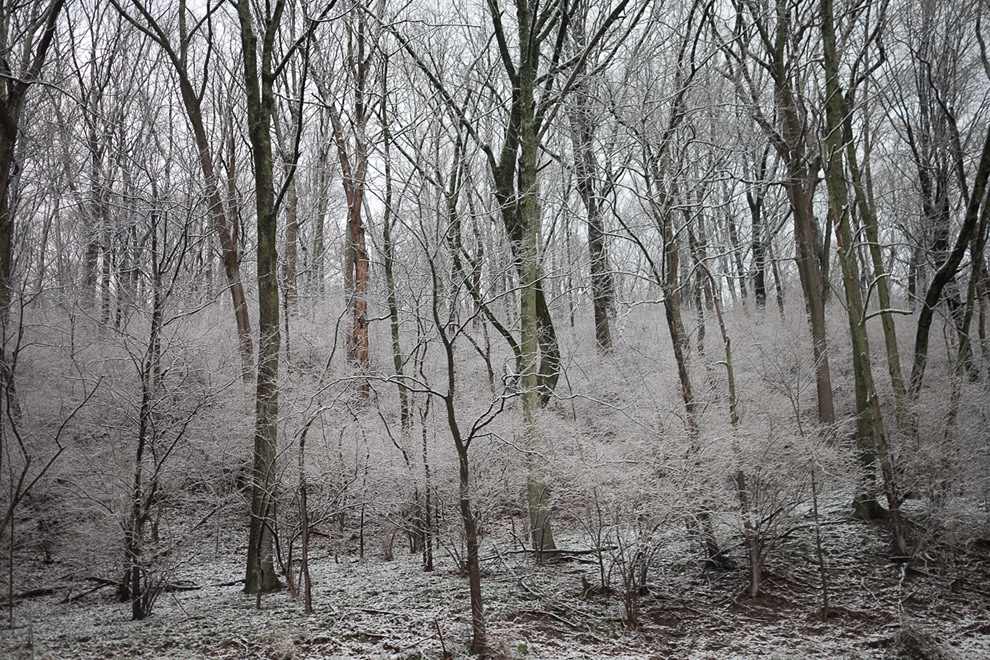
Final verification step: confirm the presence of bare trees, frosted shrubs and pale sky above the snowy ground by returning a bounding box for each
[0,0,990,654]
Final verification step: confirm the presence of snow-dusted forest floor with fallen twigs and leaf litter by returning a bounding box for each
[0,502,990,660]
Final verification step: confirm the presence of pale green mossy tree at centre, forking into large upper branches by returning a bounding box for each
[386,0,647,552]
